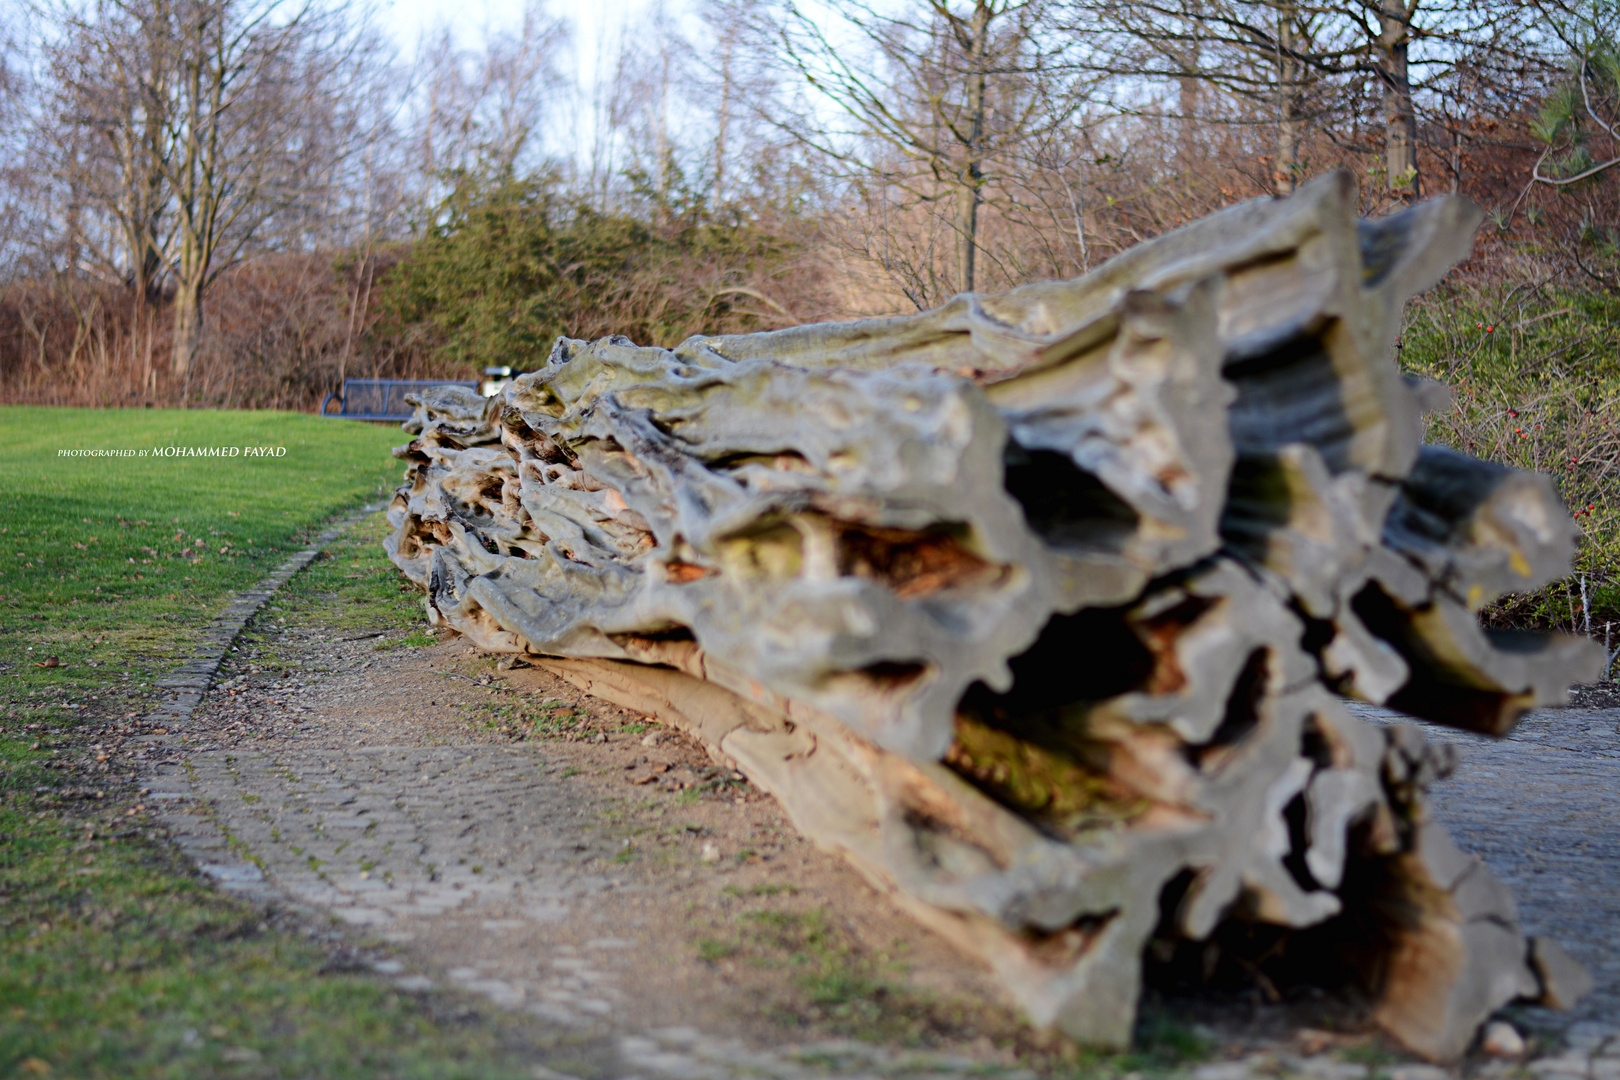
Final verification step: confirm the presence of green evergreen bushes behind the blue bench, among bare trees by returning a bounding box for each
[377,175,810,371]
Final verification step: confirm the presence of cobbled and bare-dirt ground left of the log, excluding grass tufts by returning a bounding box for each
[144,630,1032,1078]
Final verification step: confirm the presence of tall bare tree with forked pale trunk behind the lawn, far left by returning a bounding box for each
[47,0,395,377]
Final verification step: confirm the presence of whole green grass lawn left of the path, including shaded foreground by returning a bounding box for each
[0,408,550,1078]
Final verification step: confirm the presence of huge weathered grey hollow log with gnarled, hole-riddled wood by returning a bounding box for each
[389,176,1601,1059]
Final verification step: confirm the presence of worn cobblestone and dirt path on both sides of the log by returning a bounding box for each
[146,527,1620,1080]
